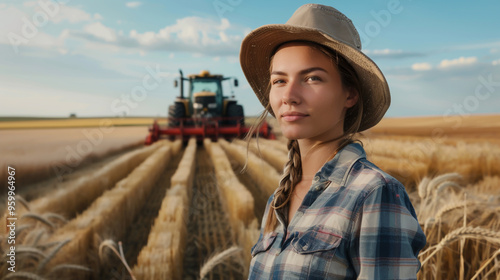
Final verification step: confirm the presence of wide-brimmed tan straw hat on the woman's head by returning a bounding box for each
[240,4,391,131]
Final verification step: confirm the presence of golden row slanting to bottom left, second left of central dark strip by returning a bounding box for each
[44,141,181,279]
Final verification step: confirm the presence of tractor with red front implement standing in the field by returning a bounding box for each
[145,70,275,145]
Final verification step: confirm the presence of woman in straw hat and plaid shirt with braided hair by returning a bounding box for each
[240,4,425,279]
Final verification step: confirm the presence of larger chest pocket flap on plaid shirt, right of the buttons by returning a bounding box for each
[292,229,342,255]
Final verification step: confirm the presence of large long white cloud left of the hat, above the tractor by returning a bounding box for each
[63,17,243,57]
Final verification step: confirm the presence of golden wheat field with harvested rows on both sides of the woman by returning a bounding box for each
[0,116,500,279]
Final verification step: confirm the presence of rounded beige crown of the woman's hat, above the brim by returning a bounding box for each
[286,4,361,50]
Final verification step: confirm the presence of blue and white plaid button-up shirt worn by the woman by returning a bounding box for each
[249,143,426,280]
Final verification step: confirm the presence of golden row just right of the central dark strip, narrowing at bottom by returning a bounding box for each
[204,139,259,278]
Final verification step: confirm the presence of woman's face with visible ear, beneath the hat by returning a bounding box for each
[269,43,358,141]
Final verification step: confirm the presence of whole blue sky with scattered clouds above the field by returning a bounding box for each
[0,0,500,117]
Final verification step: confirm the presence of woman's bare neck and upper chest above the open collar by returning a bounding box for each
[298,139,341,182]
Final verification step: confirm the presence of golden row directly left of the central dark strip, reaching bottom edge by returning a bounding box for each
[133,138,196,280]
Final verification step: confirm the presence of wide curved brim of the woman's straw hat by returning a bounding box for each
[240,24,391,131]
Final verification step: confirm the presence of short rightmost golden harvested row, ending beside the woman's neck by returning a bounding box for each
[232,139,288,173]
